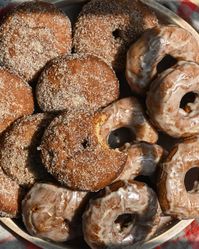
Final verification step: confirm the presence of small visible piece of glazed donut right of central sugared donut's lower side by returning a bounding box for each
[116,142,164,181]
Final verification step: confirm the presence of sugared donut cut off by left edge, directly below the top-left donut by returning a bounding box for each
[0,67,34,133]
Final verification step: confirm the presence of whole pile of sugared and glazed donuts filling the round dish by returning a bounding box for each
[0,0,199,249]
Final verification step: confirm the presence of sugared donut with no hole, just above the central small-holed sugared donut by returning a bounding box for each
[36,54,119,112]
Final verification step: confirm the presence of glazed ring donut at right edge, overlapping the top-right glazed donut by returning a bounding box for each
[146,61,199,137]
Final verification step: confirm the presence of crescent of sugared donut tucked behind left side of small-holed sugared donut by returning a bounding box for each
[0,113,53,187]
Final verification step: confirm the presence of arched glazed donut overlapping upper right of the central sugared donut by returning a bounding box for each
[96,97,158,144]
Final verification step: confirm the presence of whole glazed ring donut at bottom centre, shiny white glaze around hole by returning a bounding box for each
[82,181,160,249]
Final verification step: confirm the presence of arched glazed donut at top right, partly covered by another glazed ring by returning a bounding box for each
[126,25,199,94]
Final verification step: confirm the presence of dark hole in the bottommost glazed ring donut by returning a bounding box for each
[115,214,136,232]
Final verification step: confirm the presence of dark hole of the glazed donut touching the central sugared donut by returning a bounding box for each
[108,127,135,149]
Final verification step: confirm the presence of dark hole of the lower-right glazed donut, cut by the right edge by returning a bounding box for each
[184,167,199,193]
